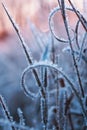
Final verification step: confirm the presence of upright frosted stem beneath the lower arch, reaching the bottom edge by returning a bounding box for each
[40,67,48,130]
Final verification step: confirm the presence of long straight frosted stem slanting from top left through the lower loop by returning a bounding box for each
[2,3,42,87]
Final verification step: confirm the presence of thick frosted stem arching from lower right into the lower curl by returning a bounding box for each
[22,62,87,123]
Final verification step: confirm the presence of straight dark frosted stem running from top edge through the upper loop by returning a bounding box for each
[58,0,84,97]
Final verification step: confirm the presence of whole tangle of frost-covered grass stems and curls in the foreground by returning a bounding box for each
[0,0,87,130]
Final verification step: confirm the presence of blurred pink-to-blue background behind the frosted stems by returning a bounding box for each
[0,0,87,129]
